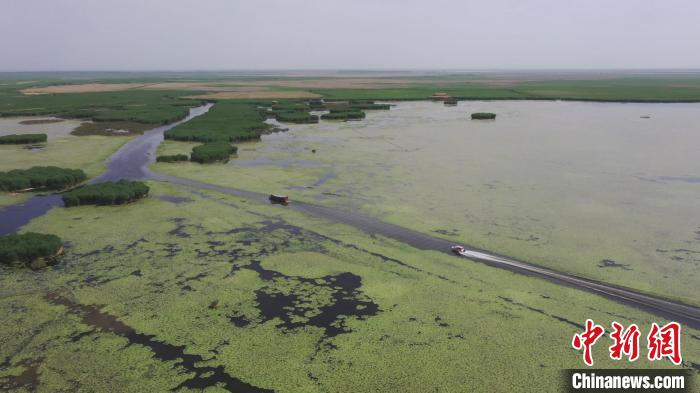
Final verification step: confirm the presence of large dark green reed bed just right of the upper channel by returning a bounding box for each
[165,101,269,142]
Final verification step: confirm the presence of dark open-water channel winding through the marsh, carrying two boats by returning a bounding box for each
[0,104,700,329]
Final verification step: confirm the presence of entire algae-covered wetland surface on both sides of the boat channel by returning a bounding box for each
[0,78,700,392]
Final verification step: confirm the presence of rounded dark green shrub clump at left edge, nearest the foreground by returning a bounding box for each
[0,232,63,265]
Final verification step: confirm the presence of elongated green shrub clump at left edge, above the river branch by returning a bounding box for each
[0,166,87,191]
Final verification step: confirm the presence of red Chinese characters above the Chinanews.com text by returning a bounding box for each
[571,319,682,366]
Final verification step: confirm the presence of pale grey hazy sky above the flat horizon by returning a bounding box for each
[0,0,700,71]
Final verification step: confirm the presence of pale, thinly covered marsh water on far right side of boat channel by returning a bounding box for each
[154,101,700,304]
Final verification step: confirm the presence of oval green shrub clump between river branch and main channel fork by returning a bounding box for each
[63,180,149,207]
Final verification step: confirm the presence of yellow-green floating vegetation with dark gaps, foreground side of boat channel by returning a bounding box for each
[0,181,700,393]
